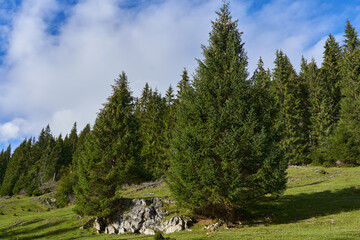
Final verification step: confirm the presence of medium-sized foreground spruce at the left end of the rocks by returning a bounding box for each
[75,72,140,229]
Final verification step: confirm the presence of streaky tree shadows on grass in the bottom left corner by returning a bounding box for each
[0,219,76,240]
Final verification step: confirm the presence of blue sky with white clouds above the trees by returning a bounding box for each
[0,0,360,148]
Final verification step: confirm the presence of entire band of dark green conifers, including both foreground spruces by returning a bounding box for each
[0,3,360,221]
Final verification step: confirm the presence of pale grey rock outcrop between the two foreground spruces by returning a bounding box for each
[94,198,192,235]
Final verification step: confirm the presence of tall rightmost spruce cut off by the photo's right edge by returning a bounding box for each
[326,21,360,165]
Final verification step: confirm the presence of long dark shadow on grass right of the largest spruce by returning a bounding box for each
[255,187,360,224]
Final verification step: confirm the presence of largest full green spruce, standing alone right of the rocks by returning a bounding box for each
[169,3,287,220]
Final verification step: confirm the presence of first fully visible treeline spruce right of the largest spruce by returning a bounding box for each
[271,50,309,164]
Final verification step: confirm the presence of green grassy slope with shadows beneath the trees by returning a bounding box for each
[0,167,360,240]
